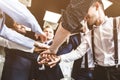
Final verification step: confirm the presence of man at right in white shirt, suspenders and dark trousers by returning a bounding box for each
[40,1,120,80]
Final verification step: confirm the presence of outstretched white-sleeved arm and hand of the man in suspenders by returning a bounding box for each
[38,37,90,68]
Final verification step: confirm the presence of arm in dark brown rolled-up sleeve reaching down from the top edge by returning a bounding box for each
[40,0,101,56]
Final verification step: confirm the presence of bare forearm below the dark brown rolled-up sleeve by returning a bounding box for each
[50,24,71,53]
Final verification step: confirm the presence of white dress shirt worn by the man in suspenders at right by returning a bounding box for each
[61,17,120,66]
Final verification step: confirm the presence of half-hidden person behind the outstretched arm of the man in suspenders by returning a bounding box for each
[71,21,95,80]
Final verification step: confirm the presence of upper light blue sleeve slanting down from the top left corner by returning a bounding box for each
[0,0,43,34]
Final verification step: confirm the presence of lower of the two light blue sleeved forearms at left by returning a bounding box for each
[0,25,35,49]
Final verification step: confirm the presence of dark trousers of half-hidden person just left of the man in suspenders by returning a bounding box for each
[75,68,93,80]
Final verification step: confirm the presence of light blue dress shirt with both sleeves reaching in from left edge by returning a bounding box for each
[0,0,43,49]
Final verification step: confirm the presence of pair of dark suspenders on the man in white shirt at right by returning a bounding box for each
[91,18,118,67]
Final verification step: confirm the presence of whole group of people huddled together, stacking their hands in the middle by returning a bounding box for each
[0,0,120,80]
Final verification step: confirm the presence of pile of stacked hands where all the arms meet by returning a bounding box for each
[34,41,60,68]
